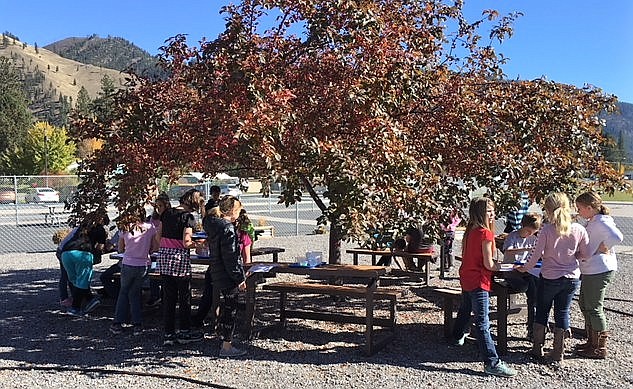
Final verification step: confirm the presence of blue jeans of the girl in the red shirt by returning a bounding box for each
[453,289,500,367]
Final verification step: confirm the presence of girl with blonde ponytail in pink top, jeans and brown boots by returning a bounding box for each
[517,193,589,361]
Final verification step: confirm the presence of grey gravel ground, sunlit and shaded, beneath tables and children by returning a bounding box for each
[0,236,633,388]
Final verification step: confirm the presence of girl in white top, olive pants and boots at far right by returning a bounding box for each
[576,192,623,359]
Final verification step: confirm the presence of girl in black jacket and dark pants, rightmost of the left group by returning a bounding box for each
[204,196,246,357]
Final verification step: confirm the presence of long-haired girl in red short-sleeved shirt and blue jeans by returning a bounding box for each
[453,197,517,377]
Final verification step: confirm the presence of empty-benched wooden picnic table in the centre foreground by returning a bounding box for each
[242,263,395,354]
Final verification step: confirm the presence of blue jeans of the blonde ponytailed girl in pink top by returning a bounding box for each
[534,276,580,330]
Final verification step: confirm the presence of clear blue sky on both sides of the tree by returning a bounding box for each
[0,0,633,103]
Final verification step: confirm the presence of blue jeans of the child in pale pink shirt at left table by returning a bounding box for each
[114,265,147,325]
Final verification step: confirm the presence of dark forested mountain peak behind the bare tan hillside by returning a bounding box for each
[44,34,164,79]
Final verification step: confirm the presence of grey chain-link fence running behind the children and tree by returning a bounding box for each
[0,176,633,253]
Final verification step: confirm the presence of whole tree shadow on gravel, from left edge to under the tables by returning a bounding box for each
[0,264,524,376]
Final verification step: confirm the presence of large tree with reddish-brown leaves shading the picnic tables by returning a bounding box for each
[69,0,621,262]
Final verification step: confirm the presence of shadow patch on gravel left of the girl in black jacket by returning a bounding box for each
[0,269,222,369]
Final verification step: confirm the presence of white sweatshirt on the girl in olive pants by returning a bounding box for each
[580,214,624,274]
